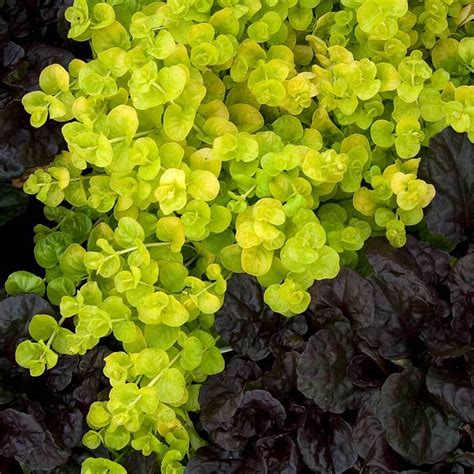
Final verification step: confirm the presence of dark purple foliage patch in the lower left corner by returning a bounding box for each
[0,294,110,473]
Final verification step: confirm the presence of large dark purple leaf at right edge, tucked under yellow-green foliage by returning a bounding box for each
[419,128,474,244]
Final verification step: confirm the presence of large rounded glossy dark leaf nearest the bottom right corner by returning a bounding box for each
[377,369,459,465]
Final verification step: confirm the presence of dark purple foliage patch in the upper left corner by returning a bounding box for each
[0,0,90,225]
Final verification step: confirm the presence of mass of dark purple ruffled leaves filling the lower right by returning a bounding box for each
[187,238,474,474]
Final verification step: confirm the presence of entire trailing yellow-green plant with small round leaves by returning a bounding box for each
[6,0,474,474]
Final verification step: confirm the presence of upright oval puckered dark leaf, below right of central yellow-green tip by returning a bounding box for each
[297,322,356,413]
